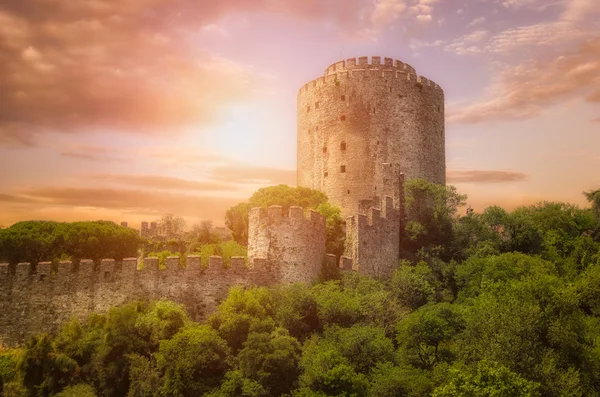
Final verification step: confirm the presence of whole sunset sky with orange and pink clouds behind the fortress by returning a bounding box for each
[0,0,600,227]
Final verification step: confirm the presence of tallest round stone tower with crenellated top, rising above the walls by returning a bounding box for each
[297,57,446,216]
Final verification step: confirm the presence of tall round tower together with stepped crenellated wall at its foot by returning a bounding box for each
[297,57,446,276]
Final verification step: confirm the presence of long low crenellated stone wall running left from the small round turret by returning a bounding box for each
[0,255,278,345]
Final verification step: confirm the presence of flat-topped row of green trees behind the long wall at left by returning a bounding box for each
[0,221,141,263]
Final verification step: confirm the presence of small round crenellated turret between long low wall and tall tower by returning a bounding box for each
[248,205,325,284]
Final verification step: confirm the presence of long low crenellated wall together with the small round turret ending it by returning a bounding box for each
[0,206,328,345]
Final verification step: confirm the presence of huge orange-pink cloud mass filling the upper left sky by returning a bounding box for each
[0,0,400,146]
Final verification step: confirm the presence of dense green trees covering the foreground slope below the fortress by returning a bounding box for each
[0,182,600,397]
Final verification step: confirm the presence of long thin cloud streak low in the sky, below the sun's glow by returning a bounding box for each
[89,174,237,191]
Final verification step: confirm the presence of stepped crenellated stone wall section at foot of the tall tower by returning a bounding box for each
[341,196,400,277]
